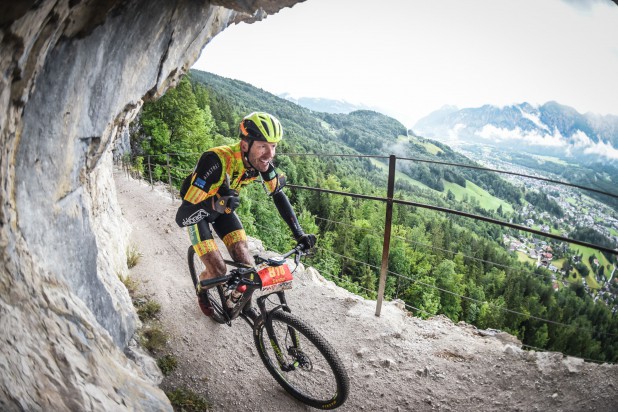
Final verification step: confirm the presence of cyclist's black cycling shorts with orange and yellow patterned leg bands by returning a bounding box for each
[187,213,247,256]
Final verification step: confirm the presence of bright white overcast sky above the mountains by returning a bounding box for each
[193,0,618,127]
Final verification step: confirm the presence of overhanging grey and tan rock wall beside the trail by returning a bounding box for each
[0,0,297,411]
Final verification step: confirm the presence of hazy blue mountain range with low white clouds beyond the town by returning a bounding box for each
[413,101,618,163]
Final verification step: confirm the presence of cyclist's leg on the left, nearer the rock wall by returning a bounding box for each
[187,219,227,280]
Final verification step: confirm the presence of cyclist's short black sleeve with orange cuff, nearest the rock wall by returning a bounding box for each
[183,152,223,204]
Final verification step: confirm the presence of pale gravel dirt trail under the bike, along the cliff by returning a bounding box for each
[115,172,618,411]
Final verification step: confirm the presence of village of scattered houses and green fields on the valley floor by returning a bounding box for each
[502,178,618,312]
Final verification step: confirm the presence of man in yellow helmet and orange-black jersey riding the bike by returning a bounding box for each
[176,112,315,316]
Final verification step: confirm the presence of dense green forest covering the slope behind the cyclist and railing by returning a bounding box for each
[127,70,618,362]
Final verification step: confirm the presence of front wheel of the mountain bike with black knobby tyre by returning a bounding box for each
[253,310,350,409]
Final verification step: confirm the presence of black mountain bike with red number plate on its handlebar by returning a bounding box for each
[188,245,350,409]
